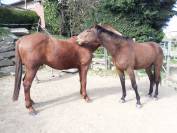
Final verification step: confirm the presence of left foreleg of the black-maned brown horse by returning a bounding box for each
[118,70,126,103]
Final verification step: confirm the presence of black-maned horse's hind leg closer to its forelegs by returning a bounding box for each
[146,66,154,96]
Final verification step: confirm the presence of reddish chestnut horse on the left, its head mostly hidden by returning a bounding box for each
[13,33,99,114]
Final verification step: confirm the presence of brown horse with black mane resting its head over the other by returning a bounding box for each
[78,25,163,107]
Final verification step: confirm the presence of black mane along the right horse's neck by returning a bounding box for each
[95,25,133,41]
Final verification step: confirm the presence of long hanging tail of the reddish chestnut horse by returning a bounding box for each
[13,40,22,101]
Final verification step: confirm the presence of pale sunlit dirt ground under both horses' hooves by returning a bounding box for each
[0,70,177,133]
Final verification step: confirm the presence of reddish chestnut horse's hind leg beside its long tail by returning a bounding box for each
[23,69,37,114]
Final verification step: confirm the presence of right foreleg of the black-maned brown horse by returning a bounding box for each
[127,69,142,108]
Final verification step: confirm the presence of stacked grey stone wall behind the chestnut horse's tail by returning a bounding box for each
[0,34,17,76]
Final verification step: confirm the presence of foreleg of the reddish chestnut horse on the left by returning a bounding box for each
[79,66,90,102]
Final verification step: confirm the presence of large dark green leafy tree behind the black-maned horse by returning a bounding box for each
[92,0,176,42]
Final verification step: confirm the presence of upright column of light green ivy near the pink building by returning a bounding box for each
[44,0,61,34]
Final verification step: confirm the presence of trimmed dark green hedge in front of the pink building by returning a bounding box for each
[0,8,39,25]
